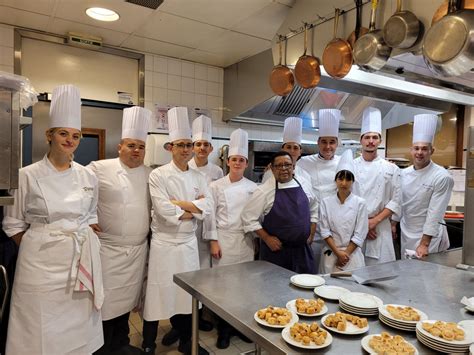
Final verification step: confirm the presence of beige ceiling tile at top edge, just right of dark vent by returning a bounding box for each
[159,0,273,28]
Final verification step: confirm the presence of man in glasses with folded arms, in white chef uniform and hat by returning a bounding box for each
[143,107,213,354]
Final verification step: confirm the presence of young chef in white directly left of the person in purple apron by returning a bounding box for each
[211,128,257,349]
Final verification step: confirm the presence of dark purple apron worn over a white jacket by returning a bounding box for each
[260,179,316,274]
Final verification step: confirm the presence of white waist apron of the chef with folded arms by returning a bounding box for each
[143,233,199,321]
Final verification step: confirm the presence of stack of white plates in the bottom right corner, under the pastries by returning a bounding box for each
[416,320,474,354]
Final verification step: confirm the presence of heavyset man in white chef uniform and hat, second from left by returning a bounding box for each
[88,106,152,354]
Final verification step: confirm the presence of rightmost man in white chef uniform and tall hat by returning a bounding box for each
[394,114,454,257]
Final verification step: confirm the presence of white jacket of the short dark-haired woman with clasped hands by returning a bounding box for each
[319,193,369,273]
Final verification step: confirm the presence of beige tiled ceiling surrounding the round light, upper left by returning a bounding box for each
[0,0,296,67]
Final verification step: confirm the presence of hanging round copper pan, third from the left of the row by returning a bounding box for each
[323,9,352,79]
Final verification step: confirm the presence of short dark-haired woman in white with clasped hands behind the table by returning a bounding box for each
[319,150,369,274]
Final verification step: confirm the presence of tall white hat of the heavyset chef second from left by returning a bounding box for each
[122,106,151,142]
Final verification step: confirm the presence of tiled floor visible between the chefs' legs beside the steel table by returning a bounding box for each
[129,313,255,355]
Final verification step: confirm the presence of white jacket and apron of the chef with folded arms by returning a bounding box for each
[143,161,213,321]
